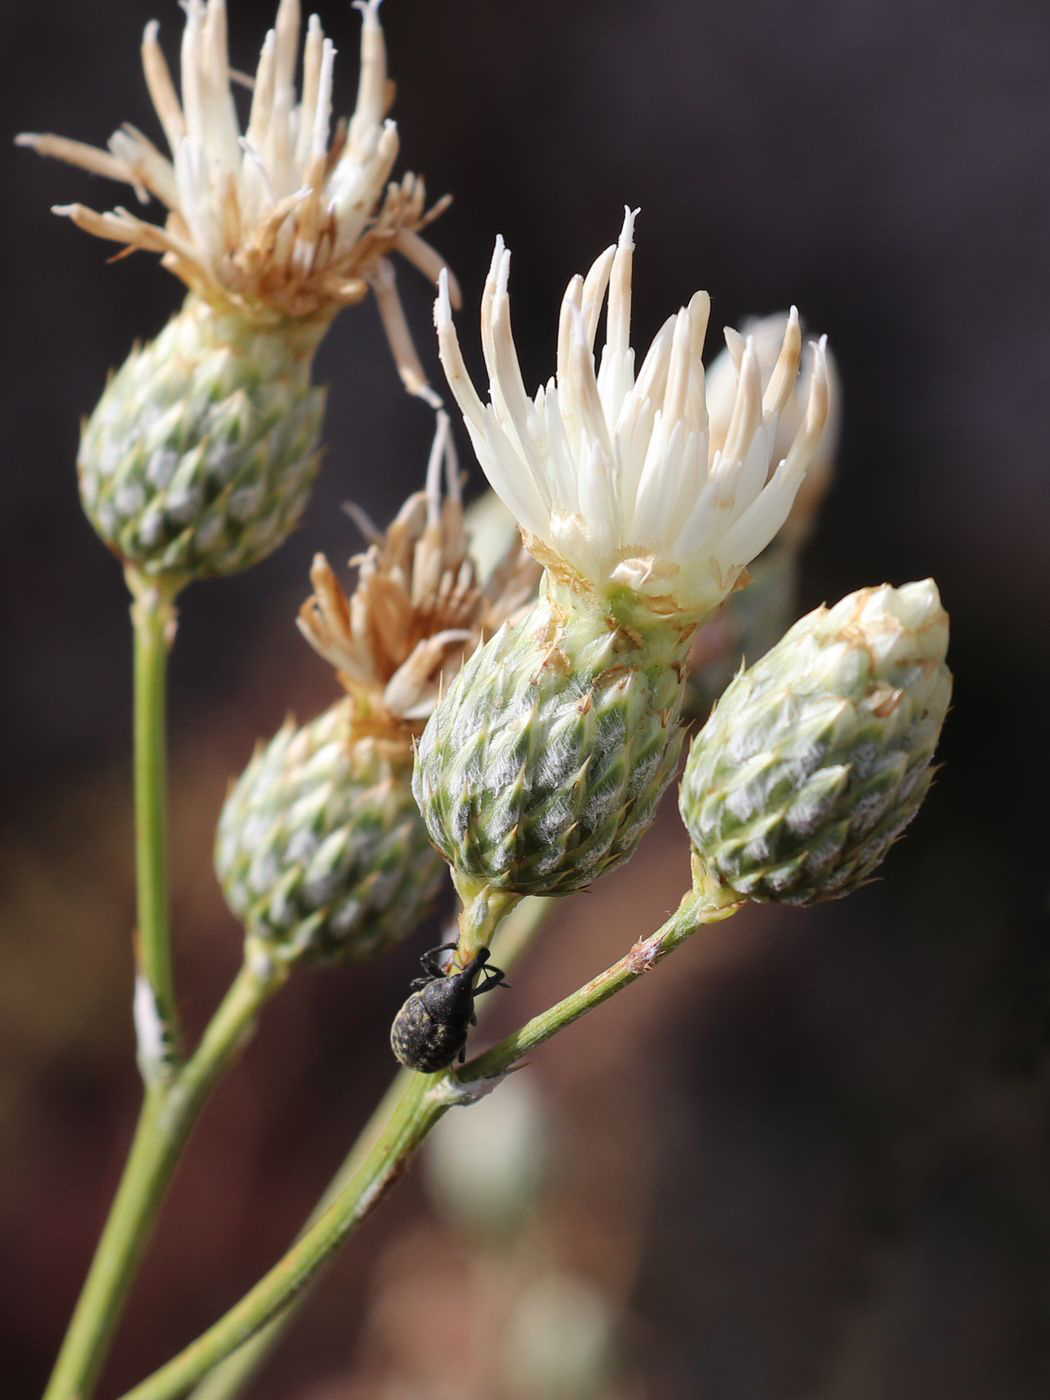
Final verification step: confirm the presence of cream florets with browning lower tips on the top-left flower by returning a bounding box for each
[17,0,456,343]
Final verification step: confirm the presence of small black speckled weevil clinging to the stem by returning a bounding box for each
[391,944,510,1072]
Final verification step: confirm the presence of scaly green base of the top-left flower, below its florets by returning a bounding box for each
[78,295,326,580]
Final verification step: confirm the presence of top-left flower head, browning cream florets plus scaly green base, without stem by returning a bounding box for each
[18,0,444,588]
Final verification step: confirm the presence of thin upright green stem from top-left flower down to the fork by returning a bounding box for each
[127,570,178,1085]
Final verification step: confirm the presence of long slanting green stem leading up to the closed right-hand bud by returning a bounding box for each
[122,892,739,1400]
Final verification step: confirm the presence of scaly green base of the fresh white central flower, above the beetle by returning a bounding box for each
[413,574,693,895]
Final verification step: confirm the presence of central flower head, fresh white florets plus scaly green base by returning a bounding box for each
[414,210,827,918]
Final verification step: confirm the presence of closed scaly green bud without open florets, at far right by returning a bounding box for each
[680,578,952,904]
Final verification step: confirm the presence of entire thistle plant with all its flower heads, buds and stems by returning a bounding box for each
[21,0,951,1400]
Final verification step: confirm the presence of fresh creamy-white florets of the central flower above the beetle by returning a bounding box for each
[435,209,827,617]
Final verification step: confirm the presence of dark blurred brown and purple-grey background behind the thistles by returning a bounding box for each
[0,0,1050,1400]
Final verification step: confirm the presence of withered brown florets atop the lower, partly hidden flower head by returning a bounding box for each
[300,413,539,732]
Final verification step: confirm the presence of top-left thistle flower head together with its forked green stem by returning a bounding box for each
[18,0,453,1396]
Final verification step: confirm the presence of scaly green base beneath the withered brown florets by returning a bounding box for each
[216,699,444,963]
